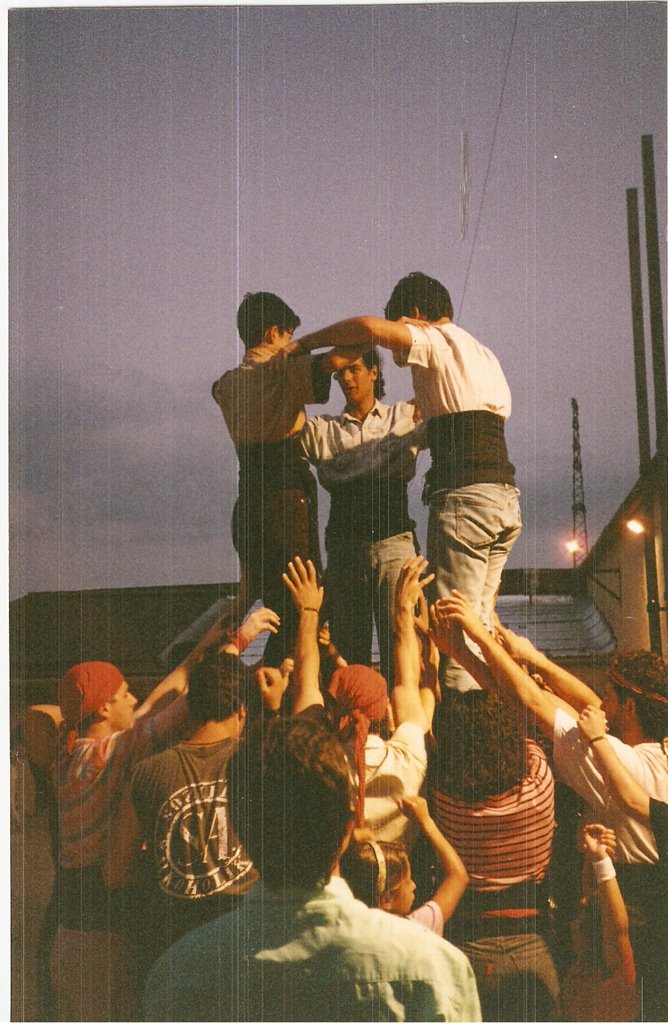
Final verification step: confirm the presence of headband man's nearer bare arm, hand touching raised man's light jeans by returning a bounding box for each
[433,591,556,737]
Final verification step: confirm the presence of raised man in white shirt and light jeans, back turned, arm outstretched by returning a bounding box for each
[288,271,521,690]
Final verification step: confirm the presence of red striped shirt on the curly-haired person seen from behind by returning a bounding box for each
[432,739,554,892]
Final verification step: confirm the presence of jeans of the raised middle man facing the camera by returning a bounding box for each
[325,530,415,687]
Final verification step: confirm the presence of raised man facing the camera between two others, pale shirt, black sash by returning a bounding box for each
[301,348,422,684]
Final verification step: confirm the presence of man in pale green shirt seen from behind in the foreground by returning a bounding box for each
[144,719,481,1021]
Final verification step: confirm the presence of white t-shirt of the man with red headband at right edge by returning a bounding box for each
[554,708,668,864]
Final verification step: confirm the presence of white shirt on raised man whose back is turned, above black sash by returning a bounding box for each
[407,324,511,421]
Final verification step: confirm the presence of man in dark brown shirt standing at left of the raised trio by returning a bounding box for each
[212,292,352,666]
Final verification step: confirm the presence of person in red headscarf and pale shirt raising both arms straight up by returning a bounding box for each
[283,557,433,845]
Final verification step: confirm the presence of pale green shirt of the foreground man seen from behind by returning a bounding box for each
[144,878,482,1021]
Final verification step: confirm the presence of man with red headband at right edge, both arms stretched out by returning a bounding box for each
[430,592,668,1020]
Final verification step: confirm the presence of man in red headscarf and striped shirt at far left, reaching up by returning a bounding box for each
[50,602,270,1021]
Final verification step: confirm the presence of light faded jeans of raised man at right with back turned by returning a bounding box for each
[427,483,521,690]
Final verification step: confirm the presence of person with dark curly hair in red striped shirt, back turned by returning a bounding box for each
[430,689,559,1021]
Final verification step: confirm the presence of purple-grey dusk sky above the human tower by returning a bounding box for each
[9,3,666,597]
